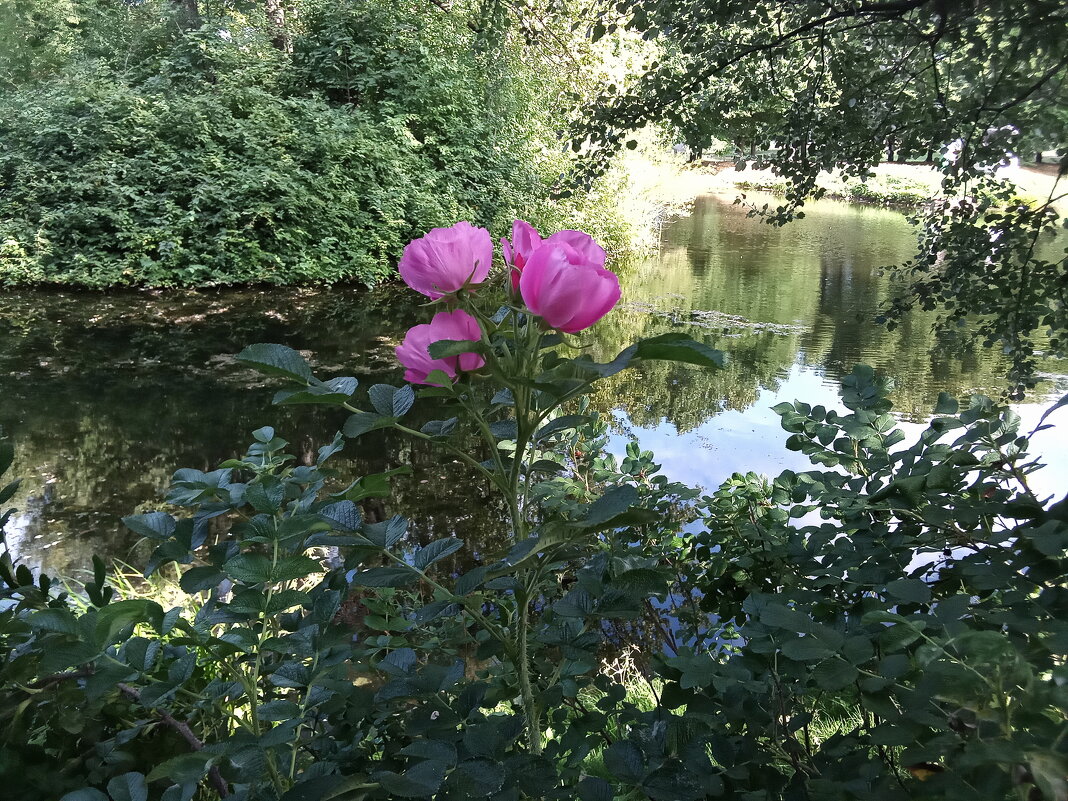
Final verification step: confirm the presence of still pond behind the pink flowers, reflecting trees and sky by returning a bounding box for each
[0,195,1068,575]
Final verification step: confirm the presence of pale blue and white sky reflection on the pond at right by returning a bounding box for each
[609,365,1068,499]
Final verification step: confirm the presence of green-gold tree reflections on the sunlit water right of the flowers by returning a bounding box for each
[596,197,1056,430]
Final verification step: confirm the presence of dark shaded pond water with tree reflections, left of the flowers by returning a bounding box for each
[0,288,499,572]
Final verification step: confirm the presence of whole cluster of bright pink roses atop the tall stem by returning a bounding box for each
[396,220,619,383]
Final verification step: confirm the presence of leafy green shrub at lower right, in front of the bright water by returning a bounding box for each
[663,367,1068,799]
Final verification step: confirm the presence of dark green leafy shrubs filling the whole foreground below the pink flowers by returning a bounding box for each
[0,360,1068,801]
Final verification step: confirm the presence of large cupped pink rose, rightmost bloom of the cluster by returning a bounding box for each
[519,243,621,333]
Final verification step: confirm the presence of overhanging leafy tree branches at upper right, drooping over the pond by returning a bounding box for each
[572,0,1068,393]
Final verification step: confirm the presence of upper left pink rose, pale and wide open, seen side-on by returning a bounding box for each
[399,222,493,300]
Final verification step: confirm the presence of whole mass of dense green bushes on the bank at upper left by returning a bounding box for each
[0,0,622,287]
